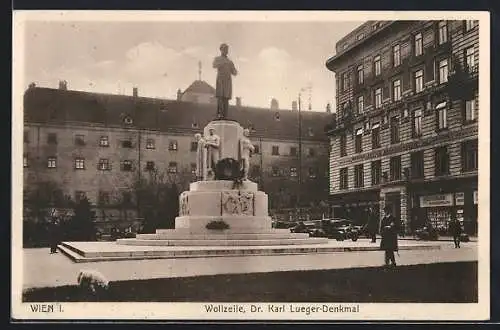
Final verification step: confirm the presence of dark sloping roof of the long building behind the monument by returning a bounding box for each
[24,87,332,141]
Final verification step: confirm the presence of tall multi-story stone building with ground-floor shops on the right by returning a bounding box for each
[326,21,479,233]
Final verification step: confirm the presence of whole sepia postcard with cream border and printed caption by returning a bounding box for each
[11,11,490,321]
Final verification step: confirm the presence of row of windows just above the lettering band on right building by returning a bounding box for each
[340,100,476,157]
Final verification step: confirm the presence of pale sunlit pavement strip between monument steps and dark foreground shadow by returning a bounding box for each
[22,242,478,288]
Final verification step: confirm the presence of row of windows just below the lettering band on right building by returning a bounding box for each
[339,140,478,190]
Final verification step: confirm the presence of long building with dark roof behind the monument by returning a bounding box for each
[24,82,330,232]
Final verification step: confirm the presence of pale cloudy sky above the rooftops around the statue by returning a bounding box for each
[25,21,363,111]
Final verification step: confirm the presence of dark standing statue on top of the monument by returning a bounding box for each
[213,44,238,119]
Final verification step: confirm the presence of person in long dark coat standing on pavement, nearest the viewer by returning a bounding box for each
[380,205,400,267]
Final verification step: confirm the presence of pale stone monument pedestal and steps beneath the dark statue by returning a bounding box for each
[117,120,327,246]
